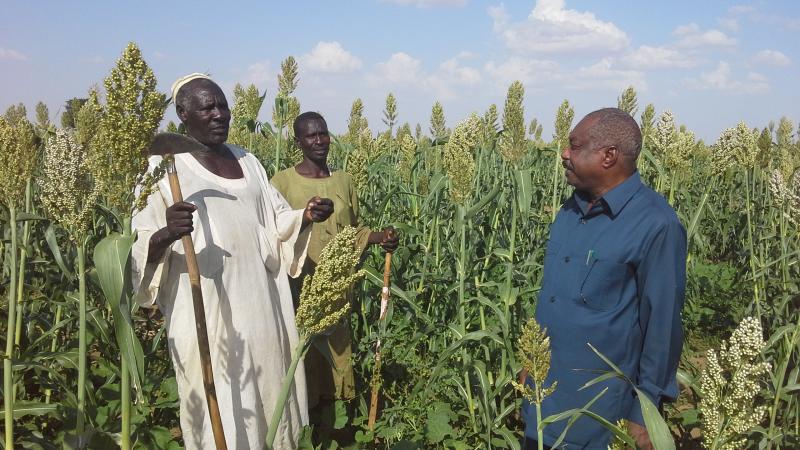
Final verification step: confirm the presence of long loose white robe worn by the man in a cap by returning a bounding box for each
[132,145,311,449]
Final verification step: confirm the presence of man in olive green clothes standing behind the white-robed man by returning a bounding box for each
[271,112,398,440]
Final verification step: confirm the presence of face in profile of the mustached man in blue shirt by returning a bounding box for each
[561,118,604,192]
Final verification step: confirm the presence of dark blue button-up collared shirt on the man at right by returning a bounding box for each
[523,173,686,450]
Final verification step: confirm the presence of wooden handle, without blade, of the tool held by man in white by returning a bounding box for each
[164,154,228,450]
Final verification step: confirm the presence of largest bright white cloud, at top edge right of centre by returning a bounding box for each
[488,0,628,53]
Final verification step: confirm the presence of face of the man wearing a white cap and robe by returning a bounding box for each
[178,82,231,145]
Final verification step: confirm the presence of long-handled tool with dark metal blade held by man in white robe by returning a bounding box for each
[150,133,228,450]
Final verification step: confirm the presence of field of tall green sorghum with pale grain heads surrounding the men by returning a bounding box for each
[0,44,800,449]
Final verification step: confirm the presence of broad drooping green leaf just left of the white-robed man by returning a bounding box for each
[94,233,144,402]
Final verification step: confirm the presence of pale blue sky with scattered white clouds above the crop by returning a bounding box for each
[0,0,800,142]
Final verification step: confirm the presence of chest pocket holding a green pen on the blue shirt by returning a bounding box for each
[576,259,630,311]
